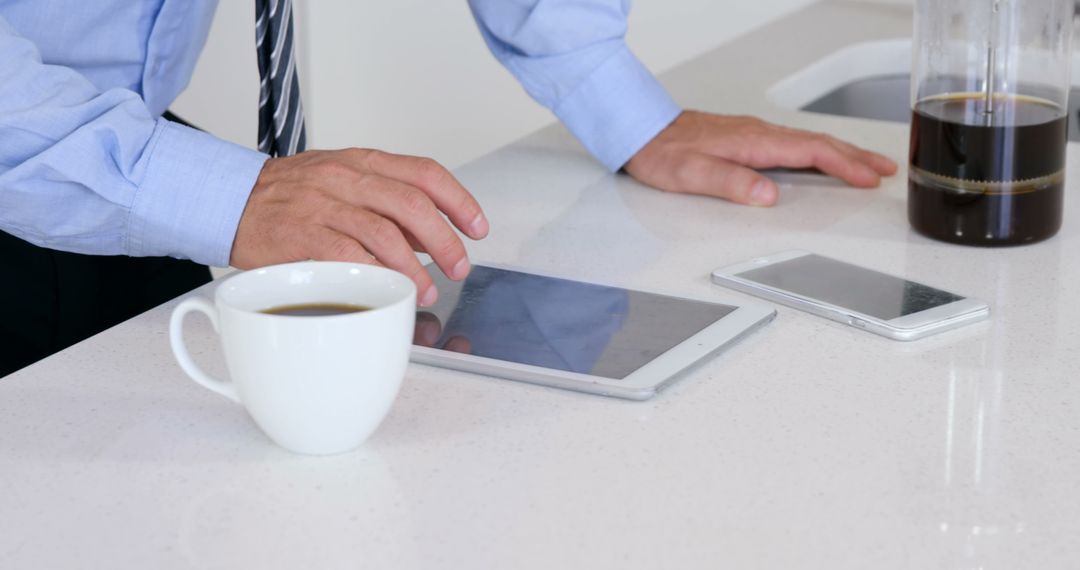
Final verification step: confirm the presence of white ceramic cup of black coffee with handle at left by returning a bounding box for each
[170,261,416,454]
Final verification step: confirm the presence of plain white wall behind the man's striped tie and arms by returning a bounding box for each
[173,0,812,167]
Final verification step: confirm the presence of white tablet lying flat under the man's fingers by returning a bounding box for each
[411,266,775,399]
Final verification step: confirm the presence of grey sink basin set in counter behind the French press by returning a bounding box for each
[799,73,1080,141]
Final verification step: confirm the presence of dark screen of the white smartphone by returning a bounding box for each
[735,254,963,321]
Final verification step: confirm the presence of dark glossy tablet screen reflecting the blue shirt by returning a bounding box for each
[414,266,735,379]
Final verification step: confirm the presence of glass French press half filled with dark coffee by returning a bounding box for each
[908,0,1074,246]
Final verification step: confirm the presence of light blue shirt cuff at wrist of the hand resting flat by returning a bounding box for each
[554,46,683,172]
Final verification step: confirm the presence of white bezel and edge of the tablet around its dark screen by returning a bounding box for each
[410,263,777,399]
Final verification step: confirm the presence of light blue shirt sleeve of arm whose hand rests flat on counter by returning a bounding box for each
[469,0,681,171]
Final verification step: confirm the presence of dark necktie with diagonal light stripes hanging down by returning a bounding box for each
[255,0,306,157]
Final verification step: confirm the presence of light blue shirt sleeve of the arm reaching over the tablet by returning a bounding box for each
[0,17,268,266]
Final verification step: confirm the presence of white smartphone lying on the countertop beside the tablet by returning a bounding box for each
[713,250,990,340]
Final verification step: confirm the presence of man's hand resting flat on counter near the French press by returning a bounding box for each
[625,111,896,206]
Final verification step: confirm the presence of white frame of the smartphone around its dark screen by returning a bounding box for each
[713,249,989,341]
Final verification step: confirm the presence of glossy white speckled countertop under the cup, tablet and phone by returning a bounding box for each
[0,2,1080,570]
